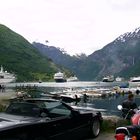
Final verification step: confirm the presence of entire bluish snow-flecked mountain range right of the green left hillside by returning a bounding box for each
[33,28,140,80]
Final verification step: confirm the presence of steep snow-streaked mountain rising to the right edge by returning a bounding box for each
[88,28,140,79]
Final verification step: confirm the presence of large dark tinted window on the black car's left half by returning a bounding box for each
[5,102,40,117]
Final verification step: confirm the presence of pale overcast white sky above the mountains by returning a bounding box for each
[0,0,140,55]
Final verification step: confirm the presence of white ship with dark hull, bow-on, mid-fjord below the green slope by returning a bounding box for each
[54,72,67,82]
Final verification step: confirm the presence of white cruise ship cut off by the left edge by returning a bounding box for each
[0,66,16,84]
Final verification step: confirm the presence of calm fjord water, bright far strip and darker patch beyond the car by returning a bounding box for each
[7,82,140,116]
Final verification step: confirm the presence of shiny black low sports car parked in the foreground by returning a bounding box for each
[0,98,103,140]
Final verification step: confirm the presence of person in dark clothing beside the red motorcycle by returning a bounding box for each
[122,93,137,119]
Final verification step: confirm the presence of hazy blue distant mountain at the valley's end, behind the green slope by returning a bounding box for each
[33,42,100,81]
